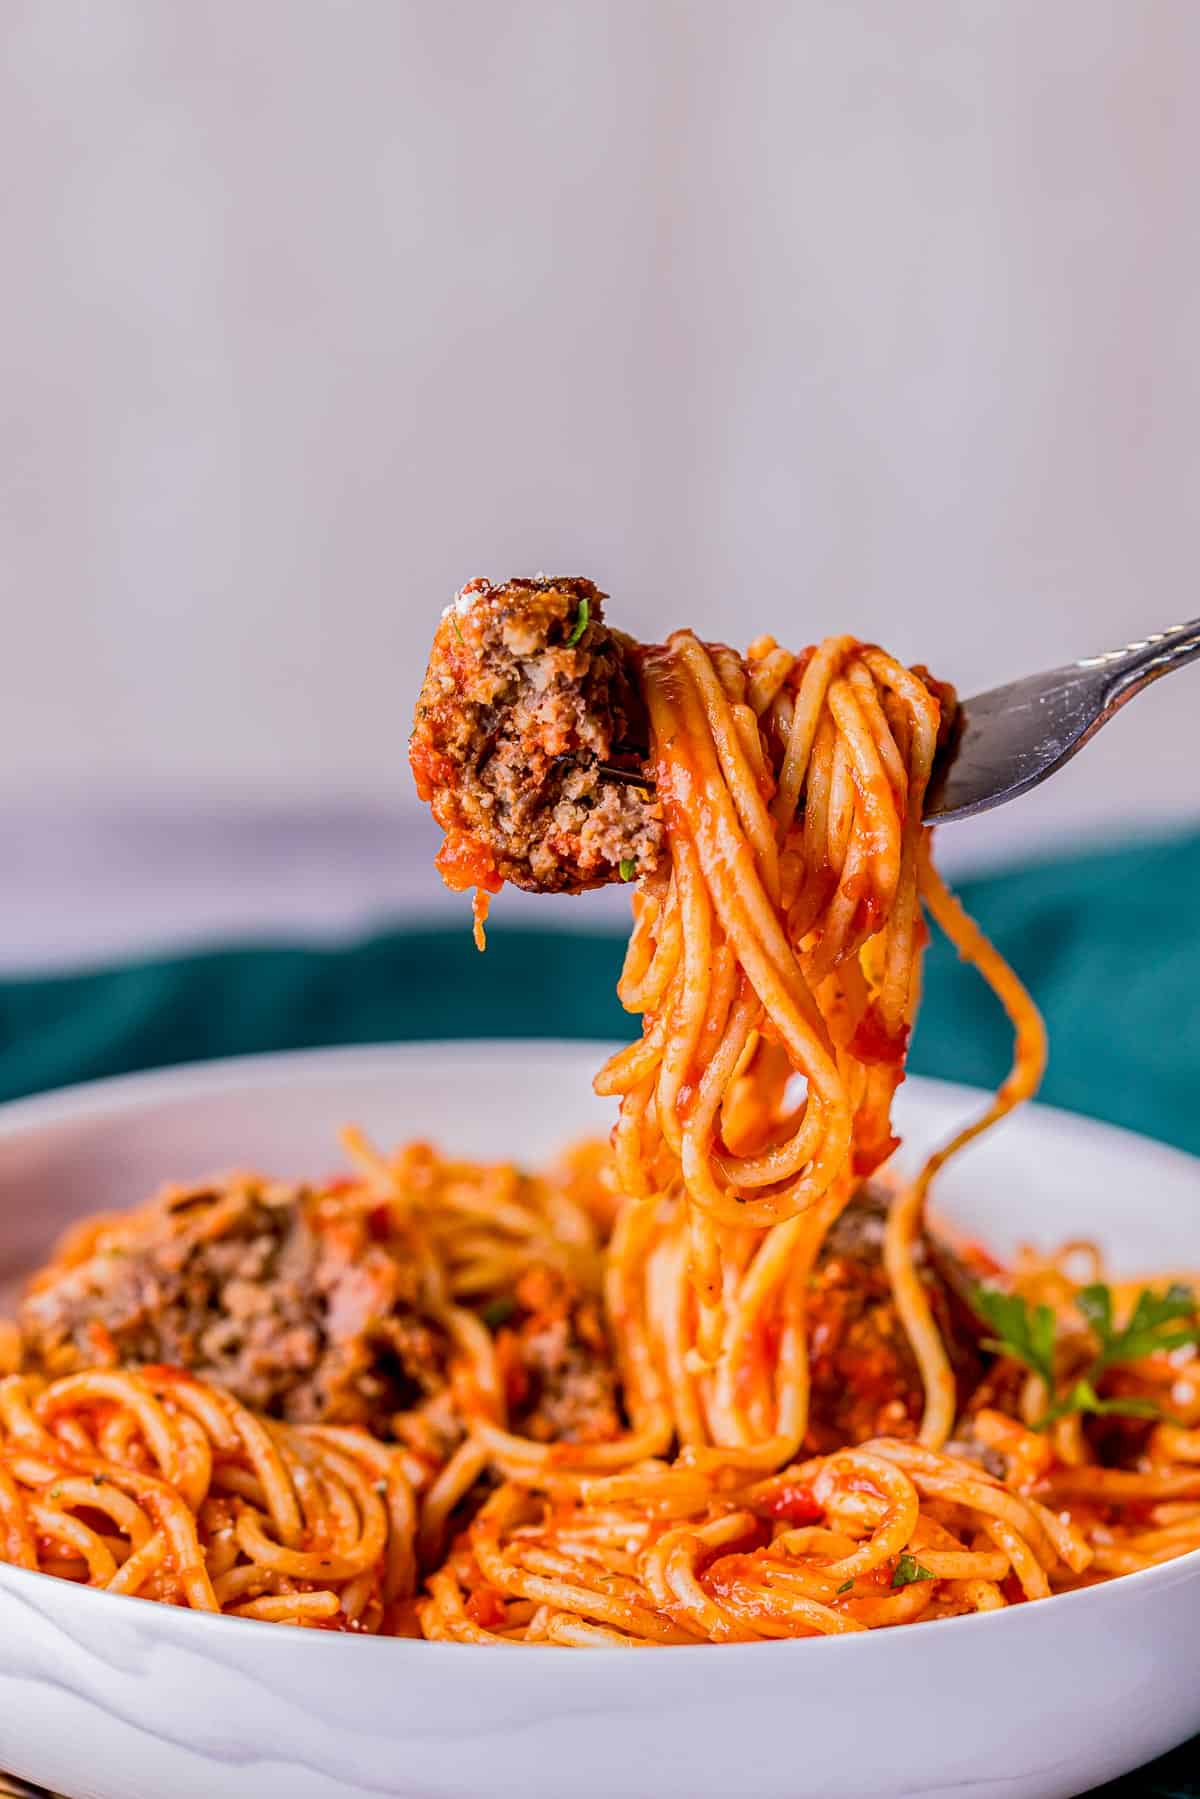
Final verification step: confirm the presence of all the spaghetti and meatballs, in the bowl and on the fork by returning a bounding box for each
[0,597,1200,1648]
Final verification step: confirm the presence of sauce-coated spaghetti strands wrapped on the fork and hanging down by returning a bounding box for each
[596,631,1043,1468]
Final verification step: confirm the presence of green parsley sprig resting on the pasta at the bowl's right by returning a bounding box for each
[973,1281,1200,1430]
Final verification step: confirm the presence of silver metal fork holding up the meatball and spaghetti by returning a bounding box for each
[925,619,1200,824]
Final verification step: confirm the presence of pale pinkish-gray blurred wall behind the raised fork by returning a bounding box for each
[0,0,1200,964]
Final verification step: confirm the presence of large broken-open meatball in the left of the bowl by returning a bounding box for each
[18,1177,450,1436]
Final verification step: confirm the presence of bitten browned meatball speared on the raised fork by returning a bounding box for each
[408,576,664,892]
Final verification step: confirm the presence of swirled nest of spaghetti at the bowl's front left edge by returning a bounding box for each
[0,1367,416,1633]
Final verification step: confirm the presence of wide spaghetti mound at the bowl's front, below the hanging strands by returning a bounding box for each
[421,1439,1092,1644]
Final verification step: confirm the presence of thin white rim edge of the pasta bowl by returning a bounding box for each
[0,1036,1200,1678]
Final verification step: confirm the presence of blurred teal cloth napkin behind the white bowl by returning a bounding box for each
[0,833,1200,1799]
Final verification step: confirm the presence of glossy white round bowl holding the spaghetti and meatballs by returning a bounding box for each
[0,1043,1200,1799]
